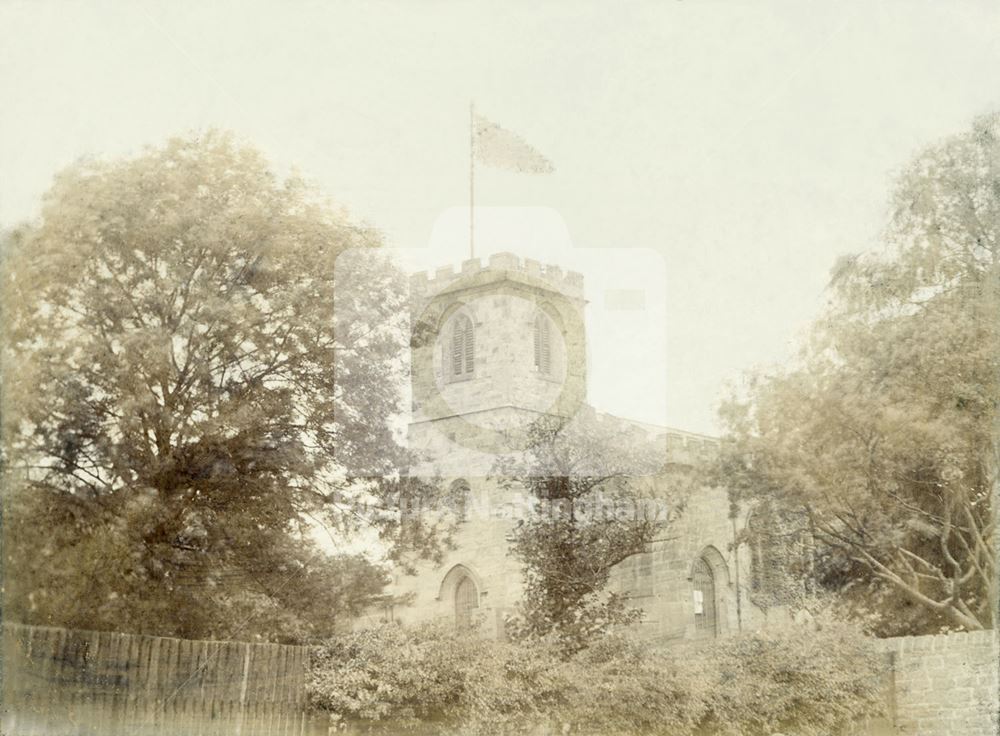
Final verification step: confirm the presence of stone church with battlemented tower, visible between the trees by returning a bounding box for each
[359,253,787,645]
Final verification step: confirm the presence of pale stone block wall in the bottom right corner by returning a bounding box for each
[882,631,1000,736]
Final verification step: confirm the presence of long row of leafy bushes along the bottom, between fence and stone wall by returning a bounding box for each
[309,620,882,736]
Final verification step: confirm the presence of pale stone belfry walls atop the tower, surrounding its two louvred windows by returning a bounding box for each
[411,254,586,424]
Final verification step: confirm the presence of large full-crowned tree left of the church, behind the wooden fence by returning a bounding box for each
[3,133,446,639]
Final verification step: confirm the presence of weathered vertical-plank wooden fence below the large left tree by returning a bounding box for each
[0,623,327,736]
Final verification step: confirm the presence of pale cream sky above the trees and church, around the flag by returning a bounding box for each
[0,0,1000,433]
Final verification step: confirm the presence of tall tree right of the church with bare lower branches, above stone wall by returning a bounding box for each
[718,114,1000,634]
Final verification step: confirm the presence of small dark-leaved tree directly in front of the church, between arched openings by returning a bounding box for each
[495,414,685,653]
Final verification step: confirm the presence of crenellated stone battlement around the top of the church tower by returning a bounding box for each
[410,253,583,300]
